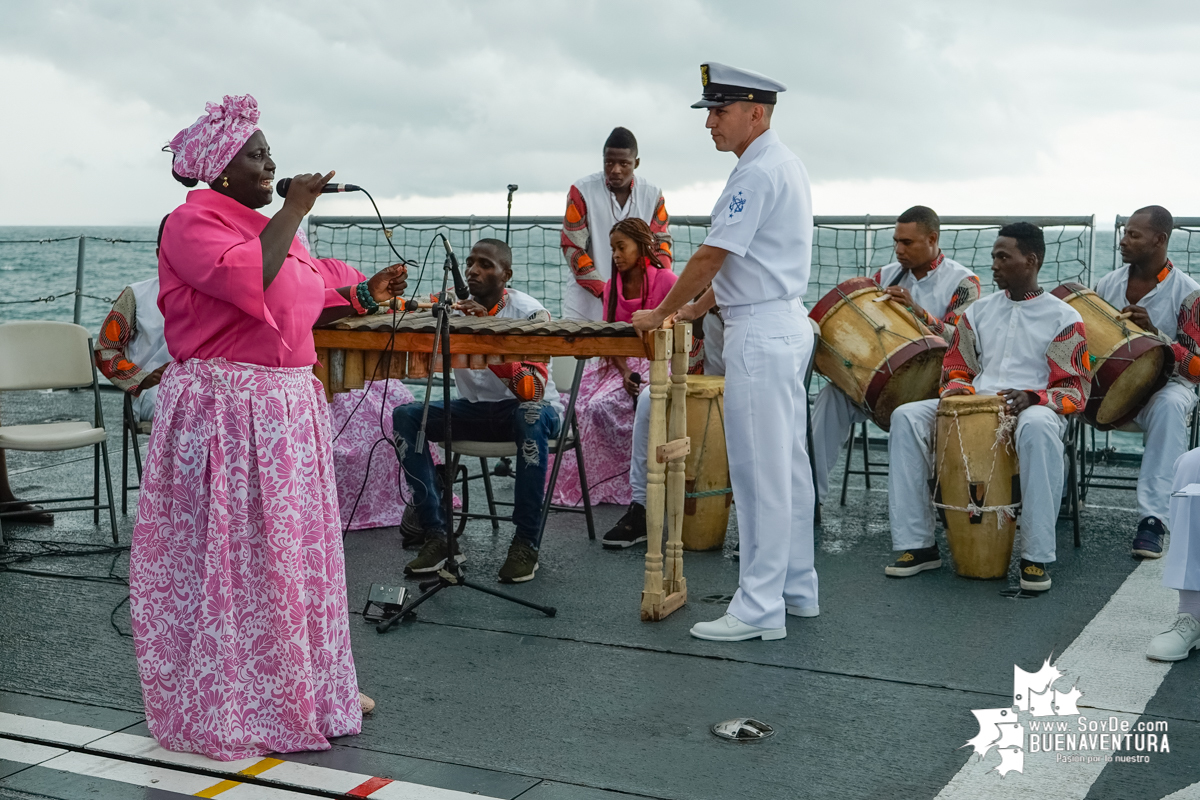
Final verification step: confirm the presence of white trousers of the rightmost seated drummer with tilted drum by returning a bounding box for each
[1134,380,1196,525]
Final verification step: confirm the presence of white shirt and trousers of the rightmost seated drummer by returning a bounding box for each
[1096,264,1200,528]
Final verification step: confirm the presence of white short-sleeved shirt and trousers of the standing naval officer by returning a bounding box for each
[704,130,817,628]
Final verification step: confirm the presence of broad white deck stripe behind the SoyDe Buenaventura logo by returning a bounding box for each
[937,560,1176,800]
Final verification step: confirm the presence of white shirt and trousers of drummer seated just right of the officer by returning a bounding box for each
[812,258,974,503]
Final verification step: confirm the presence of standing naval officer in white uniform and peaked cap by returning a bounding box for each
[634,61,818,642]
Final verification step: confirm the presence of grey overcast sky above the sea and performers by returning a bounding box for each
[0,0,1200,225]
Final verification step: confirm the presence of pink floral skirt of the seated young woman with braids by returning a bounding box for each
[554,359,650,506]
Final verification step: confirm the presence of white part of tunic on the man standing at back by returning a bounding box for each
[563,172,662,320]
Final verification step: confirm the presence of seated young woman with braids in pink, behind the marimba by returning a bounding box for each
[554,217,676,505]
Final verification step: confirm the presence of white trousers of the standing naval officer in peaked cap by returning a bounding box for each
[722,300,817,627]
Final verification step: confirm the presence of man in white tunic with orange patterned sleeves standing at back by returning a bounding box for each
[560,127,672,320]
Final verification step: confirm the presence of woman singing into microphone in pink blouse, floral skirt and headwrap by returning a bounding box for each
[130,95,406,760]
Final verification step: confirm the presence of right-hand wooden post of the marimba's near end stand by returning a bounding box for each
[662,323,691,606]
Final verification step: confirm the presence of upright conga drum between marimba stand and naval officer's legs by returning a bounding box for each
[668,375,733,551]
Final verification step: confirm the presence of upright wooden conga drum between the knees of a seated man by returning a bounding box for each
[934,395,1021,578]
